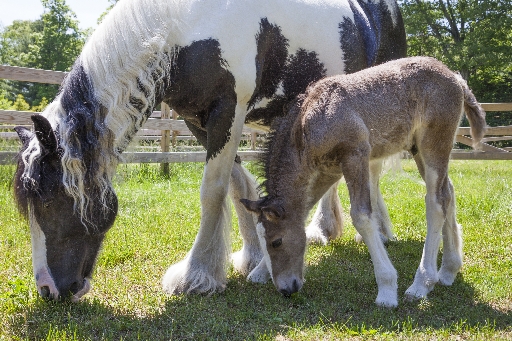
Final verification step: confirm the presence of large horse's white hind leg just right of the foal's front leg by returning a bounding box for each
[355,160,395,243]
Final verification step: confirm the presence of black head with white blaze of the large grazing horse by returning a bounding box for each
[14,115,117,300]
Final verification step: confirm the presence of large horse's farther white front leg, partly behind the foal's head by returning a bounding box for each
[229,162,270,282]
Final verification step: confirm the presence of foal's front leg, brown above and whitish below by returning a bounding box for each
[342,150,398,308]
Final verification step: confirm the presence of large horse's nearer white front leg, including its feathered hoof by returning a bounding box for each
[162,102,244,294]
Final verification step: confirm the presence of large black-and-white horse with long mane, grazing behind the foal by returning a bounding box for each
[14,0,405,300]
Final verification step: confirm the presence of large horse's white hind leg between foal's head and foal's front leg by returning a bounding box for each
[306,181,343,245]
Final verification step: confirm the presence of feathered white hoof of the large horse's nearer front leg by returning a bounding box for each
[162,259,226,295]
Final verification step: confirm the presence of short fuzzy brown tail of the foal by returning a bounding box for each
[457,75,487,149]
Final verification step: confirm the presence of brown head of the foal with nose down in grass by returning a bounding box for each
[240,198,306,297]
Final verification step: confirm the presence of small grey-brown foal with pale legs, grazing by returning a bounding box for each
[242,57,486,307]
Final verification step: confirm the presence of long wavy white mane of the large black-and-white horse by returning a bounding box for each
[21,0,190,218]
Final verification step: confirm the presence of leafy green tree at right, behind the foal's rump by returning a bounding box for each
[399,0,512,101]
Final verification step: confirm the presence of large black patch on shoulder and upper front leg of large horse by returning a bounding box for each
[160,39,237,161]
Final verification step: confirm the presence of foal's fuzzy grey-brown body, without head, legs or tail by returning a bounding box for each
[294,57,464,159]
